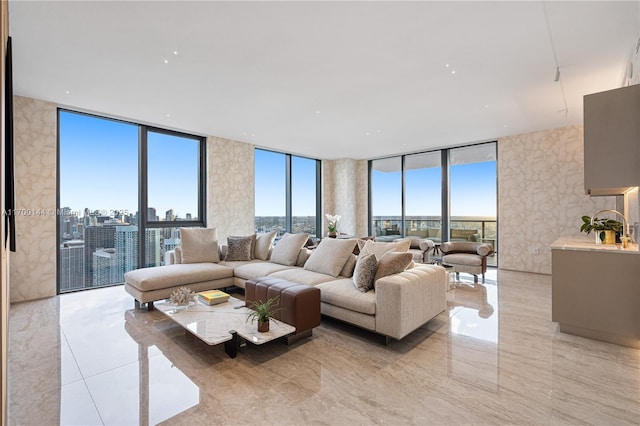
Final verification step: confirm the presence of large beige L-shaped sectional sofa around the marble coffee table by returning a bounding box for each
[125,228,447,339]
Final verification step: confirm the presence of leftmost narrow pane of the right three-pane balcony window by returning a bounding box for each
[371,157,402,241]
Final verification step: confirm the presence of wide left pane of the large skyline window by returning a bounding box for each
[58,110,138,292]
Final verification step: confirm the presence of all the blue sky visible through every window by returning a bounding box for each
[60,111,496,218]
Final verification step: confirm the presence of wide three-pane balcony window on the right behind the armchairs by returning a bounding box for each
[369,142,498,265]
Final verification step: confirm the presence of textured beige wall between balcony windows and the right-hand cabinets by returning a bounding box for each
[498,126,615,274]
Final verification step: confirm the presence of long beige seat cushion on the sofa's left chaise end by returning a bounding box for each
[124,263,233,291]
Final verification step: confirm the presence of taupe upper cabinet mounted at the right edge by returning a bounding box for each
[584,85,640,195]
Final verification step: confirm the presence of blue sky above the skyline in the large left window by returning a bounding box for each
[60,111,198,217]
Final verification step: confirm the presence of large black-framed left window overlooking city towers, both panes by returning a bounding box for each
[58,109,204,293]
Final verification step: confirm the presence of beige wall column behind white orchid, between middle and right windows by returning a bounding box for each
[322,159,369,237]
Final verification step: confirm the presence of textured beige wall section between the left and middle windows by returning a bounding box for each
[207,137,255,244]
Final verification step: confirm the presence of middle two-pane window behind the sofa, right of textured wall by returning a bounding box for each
[255,149,320,238]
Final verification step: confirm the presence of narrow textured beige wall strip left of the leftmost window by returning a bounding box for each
[10,96,56,302]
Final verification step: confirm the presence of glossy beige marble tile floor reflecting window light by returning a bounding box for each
[8,269,640,425]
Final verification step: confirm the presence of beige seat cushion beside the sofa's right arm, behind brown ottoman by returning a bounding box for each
[316,278,376,315]
